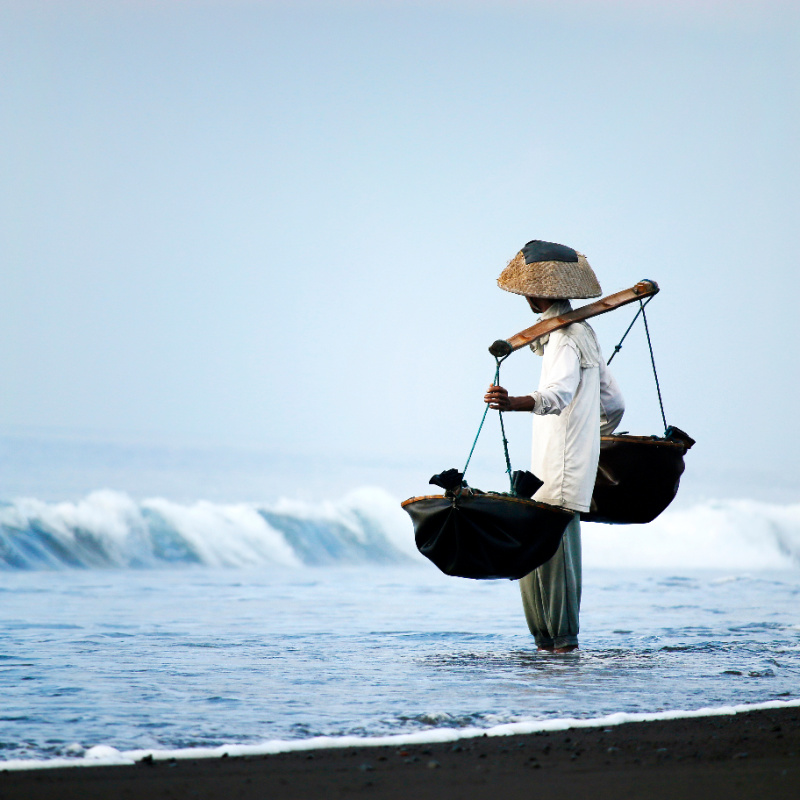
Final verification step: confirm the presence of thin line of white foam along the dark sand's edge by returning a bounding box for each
[2,700,800,770]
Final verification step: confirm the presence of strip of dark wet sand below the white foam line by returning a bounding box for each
[0,708,800,800]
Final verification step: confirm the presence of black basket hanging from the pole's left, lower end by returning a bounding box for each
[402,491,572,580]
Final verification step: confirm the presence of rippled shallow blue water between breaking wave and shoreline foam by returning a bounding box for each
[0,566,800,759]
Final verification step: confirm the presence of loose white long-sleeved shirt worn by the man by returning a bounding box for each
[531,300,625,511]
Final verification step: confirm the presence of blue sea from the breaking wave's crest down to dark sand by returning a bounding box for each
[0,488,800,768]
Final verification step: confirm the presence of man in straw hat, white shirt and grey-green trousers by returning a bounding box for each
[484,240,625,653]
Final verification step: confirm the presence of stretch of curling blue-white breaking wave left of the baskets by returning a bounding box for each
[0,489,419,569]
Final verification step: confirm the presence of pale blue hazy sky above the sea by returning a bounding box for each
[0,0,800,500]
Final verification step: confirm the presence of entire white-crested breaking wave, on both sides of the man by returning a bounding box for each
[0,488,800,570]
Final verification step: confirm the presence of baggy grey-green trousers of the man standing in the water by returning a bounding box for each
[519,513,581,649]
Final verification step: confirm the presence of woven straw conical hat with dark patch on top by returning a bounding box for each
[497,239,602,300]
